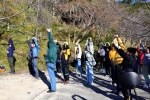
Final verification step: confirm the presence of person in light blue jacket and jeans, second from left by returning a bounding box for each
[28,37,40,79]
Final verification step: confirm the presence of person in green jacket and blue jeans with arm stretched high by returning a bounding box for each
[44,29,58,93]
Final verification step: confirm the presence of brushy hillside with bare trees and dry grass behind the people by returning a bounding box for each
[0,0,150,73]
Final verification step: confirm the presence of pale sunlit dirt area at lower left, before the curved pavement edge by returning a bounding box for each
[0,73,47,100]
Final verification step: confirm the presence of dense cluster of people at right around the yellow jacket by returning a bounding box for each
[98,35,150,100]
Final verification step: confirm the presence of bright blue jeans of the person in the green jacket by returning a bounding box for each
[47,63,56,90]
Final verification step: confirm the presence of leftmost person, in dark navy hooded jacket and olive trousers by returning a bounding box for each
[7,38,15,74]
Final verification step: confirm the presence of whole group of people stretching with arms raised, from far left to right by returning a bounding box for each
[7,29,150,100]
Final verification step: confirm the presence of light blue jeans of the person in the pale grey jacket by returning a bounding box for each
[86,61,94,84]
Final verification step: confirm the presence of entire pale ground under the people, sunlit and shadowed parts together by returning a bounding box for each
[0,71,150,100]
